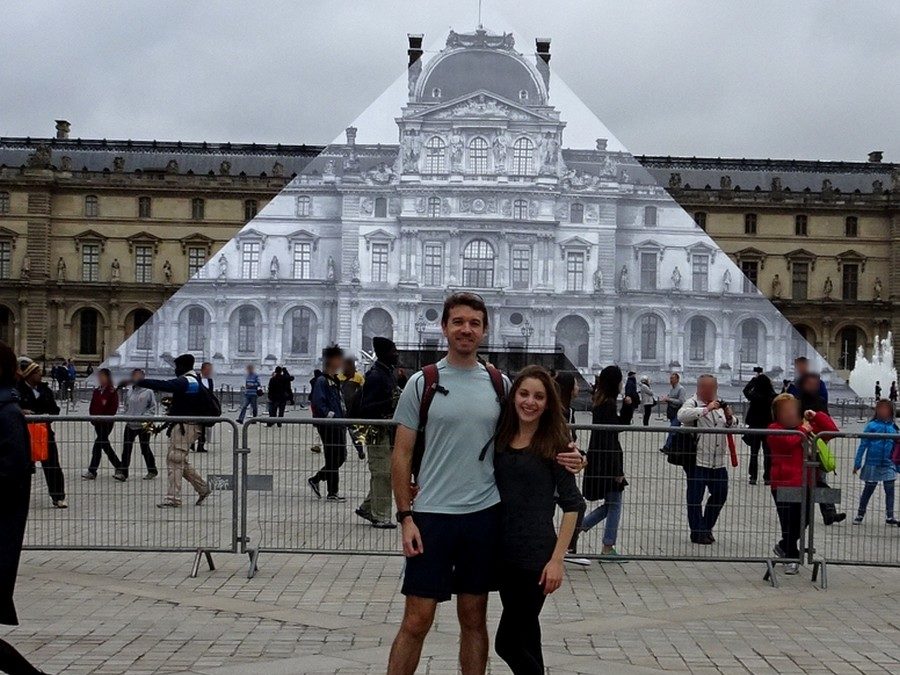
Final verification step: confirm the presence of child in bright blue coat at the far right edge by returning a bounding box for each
[853,399,898,525]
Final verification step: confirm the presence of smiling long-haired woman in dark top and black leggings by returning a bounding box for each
[494,366,584,675]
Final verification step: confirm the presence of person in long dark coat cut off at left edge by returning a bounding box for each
[0,342,48,675]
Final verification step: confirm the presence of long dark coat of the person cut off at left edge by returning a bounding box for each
[0,388,31,626]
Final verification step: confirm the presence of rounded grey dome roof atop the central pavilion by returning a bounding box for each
[418,34,547,105]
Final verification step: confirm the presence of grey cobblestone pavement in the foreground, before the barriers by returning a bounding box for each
[2,551,900,675]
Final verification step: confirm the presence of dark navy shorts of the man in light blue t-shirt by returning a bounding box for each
[403,504,500,602]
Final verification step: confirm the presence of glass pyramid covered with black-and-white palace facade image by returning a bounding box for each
[107,23,826,396]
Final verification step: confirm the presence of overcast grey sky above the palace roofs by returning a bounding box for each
[0,0,900,162]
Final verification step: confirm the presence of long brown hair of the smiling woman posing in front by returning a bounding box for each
[495,366,572,459]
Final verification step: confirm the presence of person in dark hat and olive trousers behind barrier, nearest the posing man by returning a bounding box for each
[356,337,400,529]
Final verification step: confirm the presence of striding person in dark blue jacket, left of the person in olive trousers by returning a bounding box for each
[306,345,347,502]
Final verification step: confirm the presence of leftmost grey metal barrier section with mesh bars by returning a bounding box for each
[25,416,239,575]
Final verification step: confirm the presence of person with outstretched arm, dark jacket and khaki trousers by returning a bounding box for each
[141,354,211,509]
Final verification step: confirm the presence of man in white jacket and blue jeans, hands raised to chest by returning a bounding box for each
[678,375,737,546]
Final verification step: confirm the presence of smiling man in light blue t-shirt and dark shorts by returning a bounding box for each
[388,293,585,675]
